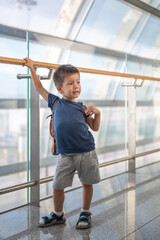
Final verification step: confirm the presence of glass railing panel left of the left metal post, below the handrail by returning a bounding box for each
[0,62,27,211]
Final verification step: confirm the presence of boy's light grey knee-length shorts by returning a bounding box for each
[53,150,100,190]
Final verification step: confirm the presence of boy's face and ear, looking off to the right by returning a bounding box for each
[57,73,81,102]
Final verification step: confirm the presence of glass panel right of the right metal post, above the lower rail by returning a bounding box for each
[127,59,160,153]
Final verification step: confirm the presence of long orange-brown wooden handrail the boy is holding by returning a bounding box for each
[0,57,160,81]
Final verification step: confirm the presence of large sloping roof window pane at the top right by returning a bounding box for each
[76,0,160,59]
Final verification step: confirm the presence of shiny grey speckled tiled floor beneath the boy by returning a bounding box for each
[0,160,160,240]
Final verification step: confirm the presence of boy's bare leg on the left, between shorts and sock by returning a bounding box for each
[53,189,64,212]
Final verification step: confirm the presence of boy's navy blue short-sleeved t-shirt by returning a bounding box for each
[48,93,95,153]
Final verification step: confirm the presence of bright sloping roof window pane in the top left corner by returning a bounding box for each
[0,0,64,34]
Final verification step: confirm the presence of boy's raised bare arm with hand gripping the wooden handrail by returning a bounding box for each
[24,58,49,102]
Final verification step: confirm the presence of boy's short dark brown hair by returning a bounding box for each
[53,64,79,86]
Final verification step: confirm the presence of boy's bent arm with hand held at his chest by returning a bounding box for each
[84,106,101,131]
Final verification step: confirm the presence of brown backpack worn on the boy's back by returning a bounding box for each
[46,98,59,155]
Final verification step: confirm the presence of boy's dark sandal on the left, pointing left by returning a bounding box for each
[38,212,66,227]
